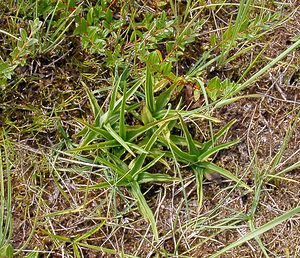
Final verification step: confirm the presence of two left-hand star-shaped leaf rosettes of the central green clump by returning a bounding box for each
[67,71,180,240]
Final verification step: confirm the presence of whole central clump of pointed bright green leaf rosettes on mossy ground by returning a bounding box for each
[68,59,251,240]
